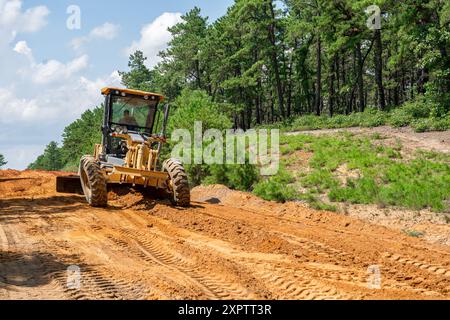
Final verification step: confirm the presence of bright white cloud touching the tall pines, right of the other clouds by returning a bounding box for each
[125,12,182,67]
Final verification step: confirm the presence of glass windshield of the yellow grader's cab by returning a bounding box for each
[111,96,158,133]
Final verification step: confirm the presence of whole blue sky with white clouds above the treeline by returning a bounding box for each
[0,0,233,169]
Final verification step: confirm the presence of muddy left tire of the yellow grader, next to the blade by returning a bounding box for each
[79,156,108,207]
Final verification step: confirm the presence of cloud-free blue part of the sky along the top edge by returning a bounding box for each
[23,0,233,76]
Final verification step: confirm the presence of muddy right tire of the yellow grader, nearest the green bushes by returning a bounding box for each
[163,159,191,207]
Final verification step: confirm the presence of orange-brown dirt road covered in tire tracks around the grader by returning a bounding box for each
[0,171,450,299]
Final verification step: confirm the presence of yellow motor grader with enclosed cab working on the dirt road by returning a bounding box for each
[56,88,190,207]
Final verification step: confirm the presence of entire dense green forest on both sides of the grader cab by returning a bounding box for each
[30,0,450,175]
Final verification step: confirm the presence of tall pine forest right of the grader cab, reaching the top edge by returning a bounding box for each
[145,0,450,129]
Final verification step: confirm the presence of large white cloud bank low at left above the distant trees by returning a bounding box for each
[0,41,120,169]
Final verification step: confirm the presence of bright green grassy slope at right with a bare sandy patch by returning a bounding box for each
[281,133,450,212]
